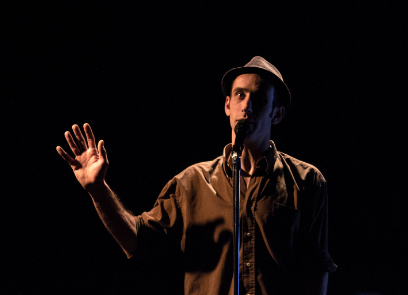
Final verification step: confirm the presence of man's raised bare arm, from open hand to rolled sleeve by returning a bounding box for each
[57,124,136,257]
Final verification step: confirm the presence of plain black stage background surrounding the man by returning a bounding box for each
[0,1,408,295]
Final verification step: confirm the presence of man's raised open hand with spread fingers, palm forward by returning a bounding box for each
[57,123,109,192]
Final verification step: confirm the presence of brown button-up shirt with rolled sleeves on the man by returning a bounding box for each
[134,142,335,295]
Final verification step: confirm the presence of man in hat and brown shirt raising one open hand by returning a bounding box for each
[57,56,336,295]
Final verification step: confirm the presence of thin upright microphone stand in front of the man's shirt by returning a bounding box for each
[232,141,242,295]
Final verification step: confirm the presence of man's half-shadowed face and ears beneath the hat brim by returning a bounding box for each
[225,74,284,146]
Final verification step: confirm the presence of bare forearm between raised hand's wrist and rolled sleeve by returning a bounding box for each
[88,183,137,257]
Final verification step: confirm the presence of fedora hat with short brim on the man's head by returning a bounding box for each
[221,56,291,109]
